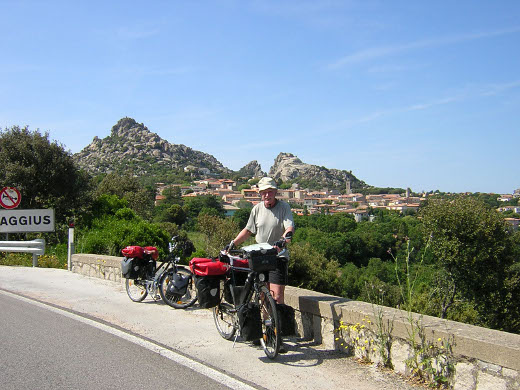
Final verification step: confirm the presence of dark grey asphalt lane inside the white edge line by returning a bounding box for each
[0,294,246,390]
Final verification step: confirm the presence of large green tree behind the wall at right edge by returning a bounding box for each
[422,196,520,331]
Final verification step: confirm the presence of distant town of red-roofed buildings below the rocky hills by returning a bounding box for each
[155,179,520,229]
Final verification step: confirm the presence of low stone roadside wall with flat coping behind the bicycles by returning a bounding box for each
[72,254,520,390]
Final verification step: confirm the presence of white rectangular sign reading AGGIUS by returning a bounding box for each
[0,209,54,233]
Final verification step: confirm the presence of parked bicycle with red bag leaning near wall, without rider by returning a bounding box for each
[121,237,197,309]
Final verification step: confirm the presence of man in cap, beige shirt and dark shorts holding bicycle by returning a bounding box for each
[226,177,294,304]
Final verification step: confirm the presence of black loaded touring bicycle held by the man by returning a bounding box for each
[213,244,284,359]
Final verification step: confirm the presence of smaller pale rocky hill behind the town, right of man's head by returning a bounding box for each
[269,153,368,189]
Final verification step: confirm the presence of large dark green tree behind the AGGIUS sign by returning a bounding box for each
[0,126,90,235]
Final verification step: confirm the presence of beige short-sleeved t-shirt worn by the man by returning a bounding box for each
[246,200,294,245]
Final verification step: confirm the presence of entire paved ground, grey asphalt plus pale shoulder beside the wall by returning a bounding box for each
[0,266,417,390]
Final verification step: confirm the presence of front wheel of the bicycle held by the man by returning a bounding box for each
[255,286,281,359]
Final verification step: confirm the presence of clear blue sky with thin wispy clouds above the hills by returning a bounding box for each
[0,0,520,193]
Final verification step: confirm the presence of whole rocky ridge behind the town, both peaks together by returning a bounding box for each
[73,118,367,189]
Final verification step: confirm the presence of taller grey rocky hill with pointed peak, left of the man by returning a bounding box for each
[73,118,232,176]
